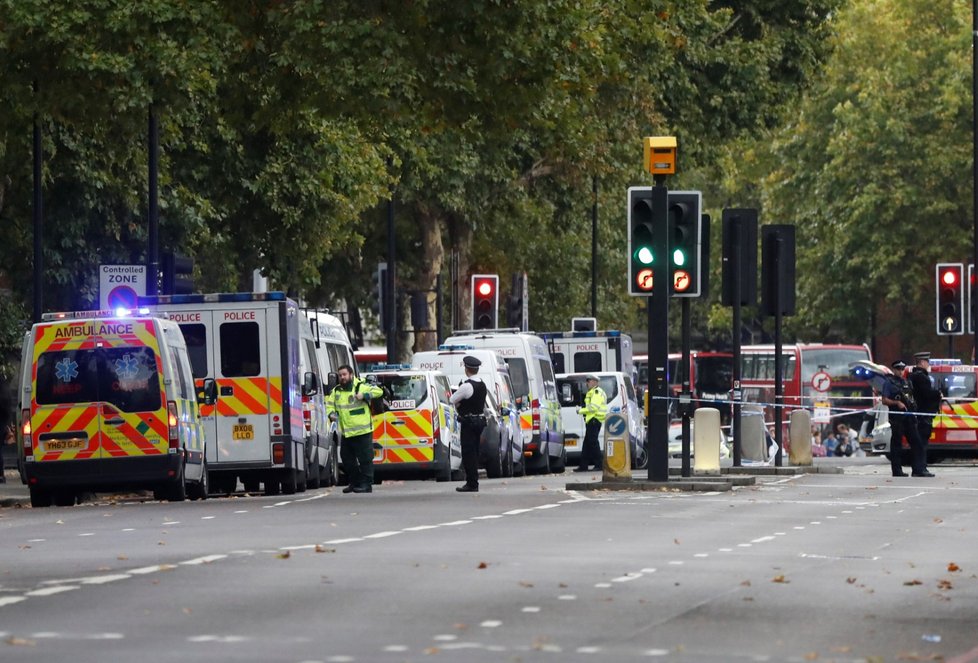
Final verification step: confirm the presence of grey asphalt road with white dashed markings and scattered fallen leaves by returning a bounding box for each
[0,459,978,663]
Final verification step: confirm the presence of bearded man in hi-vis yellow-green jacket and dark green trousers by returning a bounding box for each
[326,364,384,493]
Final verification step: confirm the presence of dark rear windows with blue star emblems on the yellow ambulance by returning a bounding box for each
[37,347,160,412]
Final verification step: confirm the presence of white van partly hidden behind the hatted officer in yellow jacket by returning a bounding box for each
[557,371,649,469]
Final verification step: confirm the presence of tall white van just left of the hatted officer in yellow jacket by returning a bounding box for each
[445,329,567,474]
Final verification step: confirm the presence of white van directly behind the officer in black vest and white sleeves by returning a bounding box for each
[411,344,530,479]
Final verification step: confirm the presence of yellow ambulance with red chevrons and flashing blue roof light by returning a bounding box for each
[19,309,216,507]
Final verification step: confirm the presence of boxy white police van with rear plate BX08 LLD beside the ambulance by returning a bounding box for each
[139,292,306,495]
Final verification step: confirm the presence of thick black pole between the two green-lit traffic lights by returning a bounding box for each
[646,180,672,481]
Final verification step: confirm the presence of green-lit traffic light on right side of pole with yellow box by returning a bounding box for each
[669,191,703,297]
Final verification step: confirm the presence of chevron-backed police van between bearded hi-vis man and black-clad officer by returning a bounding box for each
[366,365,462,481]
